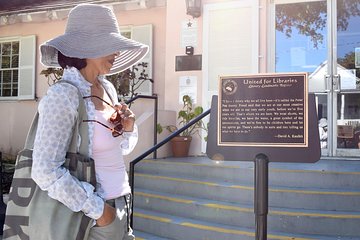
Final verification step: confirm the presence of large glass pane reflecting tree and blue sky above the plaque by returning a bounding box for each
[269,0,328,92]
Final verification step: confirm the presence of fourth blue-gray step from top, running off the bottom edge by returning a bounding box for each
[134,208,359,240]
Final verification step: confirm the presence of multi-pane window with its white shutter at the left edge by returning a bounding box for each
[0,36,35,100]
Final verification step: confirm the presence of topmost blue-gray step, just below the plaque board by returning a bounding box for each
[136,157,360,189]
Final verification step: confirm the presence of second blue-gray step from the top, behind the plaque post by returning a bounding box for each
[135,173,360,211]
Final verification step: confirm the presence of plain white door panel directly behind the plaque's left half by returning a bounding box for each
[202,0,259,152]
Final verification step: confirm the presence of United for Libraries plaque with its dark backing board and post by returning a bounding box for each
[206,72,321,240]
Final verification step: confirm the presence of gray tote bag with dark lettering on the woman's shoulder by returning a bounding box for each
[3,80,96,240]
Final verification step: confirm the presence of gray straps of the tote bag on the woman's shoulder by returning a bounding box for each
[25,80,89,156]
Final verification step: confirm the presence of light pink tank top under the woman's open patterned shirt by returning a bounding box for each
[92,110,131,200]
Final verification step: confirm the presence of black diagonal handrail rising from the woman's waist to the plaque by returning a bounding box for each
[129,109,211,227]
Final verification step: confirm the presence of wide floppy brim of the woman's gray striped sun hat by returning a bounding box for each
[40,33,149,75]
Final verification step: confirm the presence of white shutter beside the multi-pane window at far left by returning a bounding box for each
[18,35,36,100]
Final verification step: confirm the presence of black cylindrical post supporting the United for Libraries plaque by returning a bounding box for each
[254,153,269,240]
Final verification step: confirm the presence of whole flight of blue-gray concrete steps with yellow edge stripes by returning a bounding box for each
[134,157,360,240]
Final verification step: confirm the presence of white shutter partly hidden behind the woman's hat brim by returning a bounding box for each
[131,24,153,95]
